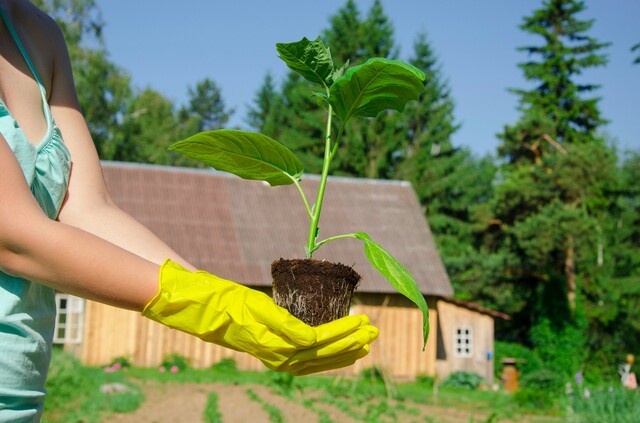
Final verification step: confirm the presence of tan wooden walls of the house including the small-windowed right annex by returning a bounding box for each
[76,294,493,380]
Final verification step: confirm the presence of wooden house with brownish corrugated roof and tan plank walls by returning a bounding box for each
[56,162,504,382]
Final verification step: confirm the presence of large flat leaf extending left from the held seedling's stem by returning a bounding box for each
[169,129,303,186]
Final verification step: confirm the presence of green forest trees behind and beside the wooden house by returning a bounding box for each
[41,0,640,380]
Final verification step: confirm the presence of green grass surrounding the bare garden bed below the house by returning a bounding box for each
[43,351,640,423]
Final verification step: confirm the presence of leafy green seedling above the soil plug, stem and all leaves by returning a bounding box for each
[169,37,429,345]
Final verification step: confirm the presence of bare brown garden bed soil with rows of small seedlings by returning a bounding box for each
[102,382,561,423]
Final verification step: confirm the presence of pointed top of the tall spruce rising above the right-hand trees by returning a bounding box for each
[499,0,609,163]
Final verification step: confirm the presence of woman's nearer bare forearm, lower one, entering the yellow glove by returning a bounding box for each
[0,135,159,311]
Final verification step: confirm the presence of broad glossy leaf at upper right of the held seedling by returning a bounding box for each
[329,58,425,122]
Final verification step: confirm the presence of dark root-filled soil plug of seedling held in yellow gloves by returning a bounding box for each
[271,259,360,326]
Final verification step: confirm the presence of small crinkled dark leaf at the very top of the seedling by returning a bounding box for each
[276,37,334,87]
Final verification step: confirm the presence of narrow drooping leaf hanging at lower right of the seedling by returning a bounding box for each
[354,232,429,351]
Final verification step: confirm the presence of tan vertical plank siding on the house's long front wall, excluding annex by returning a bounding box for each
[75,294,437,380]
